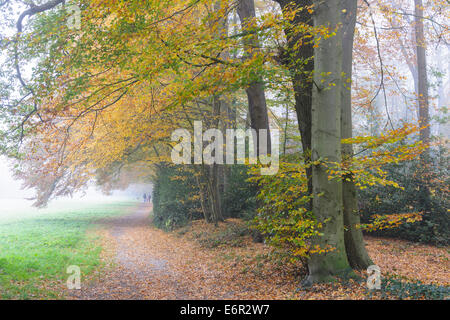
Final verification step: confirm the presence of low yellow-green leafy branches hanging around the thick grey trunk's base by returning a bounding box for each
[252,154,328,262]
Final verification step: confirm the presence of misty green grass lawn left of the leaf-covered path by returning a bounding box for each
[0,202,136,299]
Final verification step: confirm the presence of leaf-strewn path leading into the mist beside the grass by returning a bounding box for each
[67,204,231,300]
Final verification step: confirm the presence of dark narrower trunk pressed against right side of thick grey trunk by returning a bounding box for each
[341,0,373,270]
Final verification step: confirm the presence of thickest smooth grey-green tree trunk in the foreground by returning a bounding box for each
[304,0,353,285]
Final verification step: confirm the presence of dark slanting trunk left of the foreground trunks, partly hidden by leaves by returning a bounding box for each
[237,0,271,156]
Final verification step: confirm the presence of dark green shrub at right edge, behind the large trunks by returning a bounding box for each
[359,152,450,245]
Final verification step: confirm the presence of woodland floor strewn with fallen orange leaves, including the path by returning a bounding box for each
[66,204,450,299]
